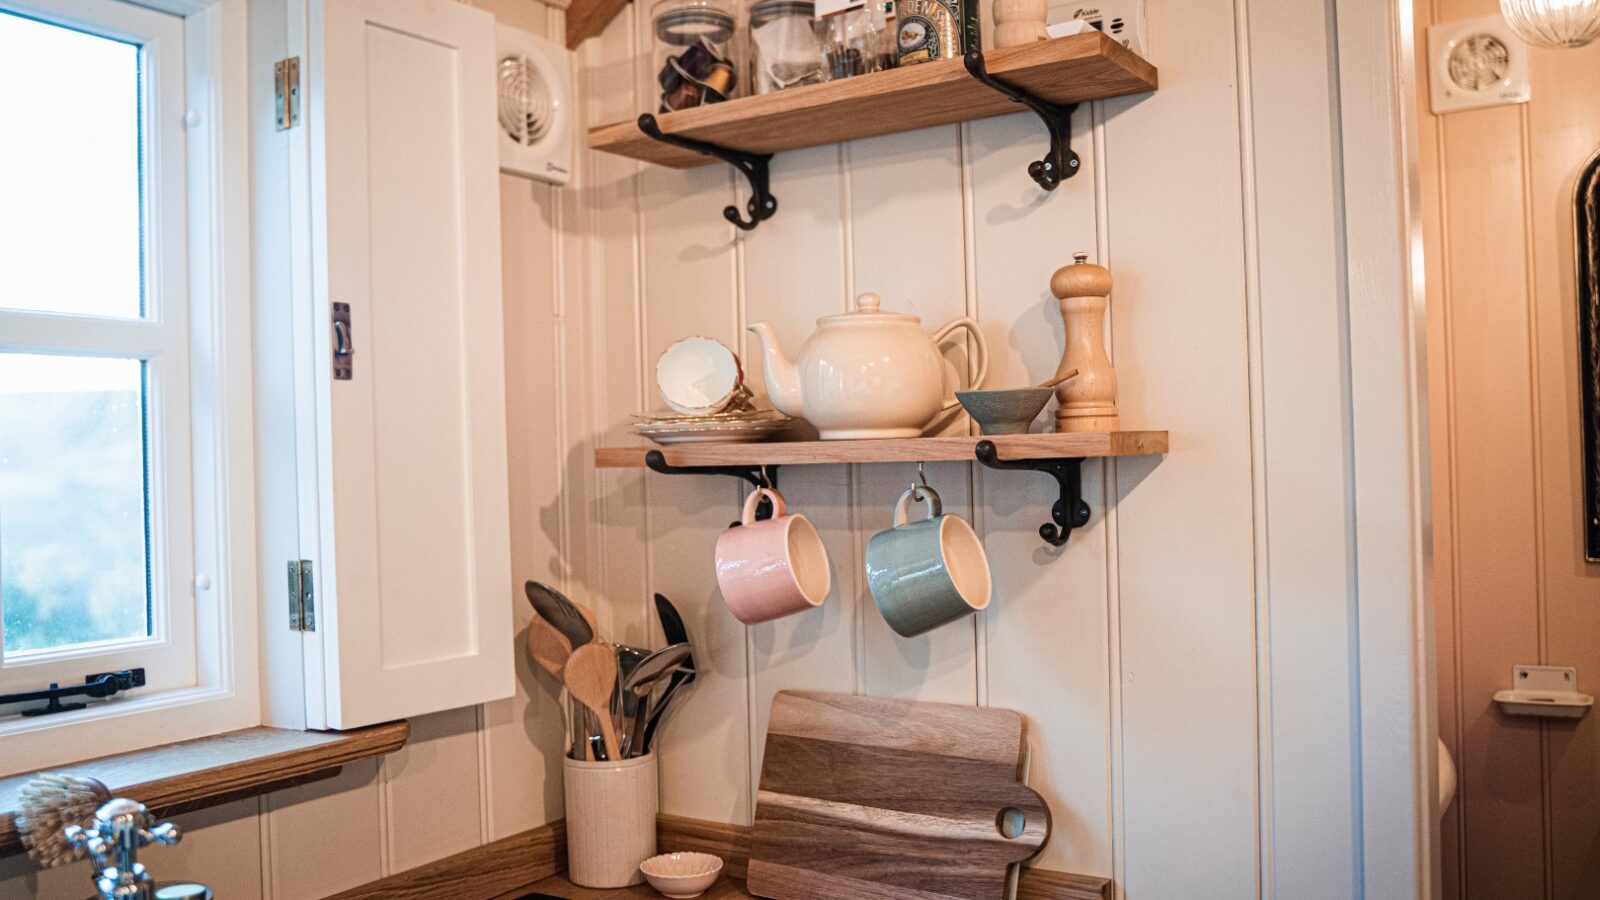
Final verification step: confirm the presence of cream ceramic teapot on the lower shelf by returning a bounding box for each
[750,293,989,440]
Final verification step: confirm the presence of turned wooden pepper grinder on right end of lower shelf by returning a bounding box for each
[1050,253,1117,431]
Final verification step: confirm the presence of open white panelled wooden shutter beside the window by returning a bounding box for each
[306,0,514,729]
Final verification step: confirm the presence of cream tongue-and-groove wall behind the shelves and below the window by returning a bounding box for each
[0,0,1416,900]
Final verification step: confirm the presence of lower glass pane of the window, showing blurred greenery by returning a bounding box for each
[0,354,150,653]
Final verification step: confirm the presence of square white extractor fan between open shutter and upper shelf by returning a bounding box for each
[494,26,573,184]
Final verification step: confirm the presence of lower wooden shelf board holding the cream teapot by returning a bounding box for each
[595,431,1166,469]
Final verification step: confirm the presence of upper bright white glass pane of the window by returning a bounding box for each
[0,13,144,317]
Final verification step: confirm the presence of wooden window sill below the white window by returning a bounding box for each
[0,721,411,857]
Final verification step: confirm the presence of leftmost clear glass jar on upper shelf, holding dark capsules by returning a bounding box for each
[650,0,739,112]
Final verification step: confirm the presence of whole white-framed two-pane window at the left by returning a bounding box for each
[0,0,250,773]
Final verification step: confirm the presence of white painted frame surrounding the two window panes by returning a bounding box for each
[0,0,261,773]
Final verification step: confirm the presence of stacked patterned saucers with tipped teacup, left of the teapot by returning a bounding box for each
[634,338,792,444]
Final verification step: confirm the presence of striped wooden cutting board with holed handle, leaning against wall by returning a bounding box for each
[749,690,1050,900]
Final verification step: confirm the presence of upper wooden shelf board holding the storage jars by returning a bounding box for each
[589,32,1157,168]
